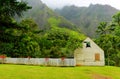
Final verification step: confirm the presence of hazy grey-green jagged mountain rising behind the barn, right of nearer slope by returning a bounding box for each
[55,4,119,37]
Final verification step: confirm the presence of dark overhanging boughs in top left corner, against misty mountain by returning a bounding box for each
[0,0,31,18]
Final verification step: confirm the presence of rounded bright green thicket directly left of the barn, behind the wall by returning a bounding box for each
[40,27,85,58]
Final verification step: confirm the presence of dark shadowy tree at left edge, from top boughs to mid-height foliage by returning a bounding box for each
[0,0,31,41]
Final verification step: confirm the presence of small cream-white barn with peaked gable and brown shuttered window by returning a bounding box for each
[74,38,105,66]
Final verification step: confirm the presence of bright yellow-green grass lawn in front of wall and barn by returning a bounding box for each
[0,64,120,79]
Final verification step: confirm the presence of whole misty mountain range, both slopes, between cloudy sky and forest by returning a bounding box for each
[18,0,119,37]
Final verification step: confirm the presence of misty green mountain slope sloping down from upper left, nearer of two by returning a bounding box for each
[18,0,76,30]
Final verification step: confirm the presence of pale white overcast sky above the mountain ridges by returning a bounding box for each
[42,0,120,10]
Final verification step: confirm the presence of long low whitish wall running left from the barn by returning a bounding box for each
[0,58,76,66]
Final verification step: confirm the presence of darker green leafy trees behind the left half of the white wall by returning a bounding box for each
[0,19,40,57]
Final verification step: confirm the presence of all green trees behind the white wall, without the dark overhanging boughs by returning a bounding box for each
[0,13,85,58]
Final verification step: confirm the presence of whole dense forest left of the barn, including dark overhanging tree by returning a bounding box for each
[0,0,85,58]
